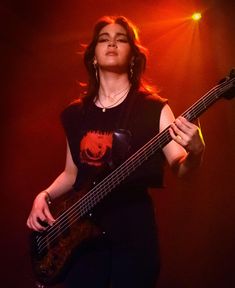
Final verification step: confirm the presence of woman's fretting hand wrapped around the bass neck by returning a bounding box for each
[169,116,205,155]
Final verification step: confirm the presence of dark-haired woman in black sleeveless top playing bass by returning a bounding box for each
[27,17,204,288]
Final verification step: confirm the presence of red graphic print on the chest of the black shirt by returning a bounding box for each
[80,131,113,167]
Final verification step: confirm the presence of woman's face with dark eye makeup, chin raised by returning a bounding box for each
[95,24,132,73]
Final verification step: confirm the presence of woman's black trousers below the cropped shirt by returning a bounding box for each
[65,192,160,288]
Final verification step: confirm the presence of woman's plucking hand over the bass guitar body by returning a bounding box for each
[27,191,55,231]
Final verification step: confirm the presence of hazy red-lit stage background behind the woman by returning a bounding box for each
[0,0,235,288]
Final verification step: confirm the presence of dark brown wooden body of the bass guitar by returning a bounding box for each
[30,191,101,285]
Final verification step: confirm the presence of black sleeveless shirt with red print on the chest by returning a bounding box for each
[61,92,166,190]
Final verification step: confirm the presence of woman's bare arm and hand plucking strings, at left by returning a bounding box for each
[27,144,77,231]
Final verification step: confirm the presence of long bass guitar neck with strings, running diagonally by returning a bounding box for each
[56,79,234,230]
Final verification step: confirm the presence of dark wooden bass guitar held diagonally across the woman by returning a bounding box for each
[30,69,235,287]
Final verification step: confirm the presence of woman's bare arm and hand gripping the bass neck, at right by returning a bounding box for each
[160,105,205,177]
